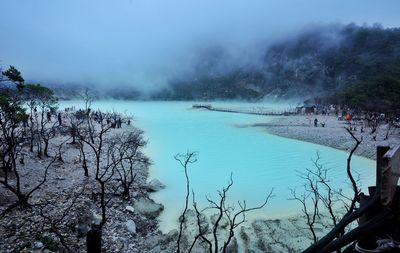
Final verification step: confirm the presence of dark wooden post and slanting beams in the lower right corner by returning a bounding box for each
[304,144,400,253]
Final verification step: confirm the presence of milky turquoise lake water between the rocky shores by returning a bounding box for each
[61,100,375,232]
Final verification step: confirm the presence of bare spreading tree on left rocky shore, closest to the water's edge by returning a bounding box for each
[77,110,145,228]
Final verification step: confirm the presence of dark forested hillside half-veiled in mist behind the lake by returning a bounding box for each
[154,24,400,108]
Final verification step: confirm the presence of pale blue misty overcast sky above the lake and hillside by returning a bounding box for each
[0,0,400,89]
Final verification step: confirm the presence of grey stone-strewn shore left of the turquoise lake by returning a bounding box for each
[0,113,175,253]
